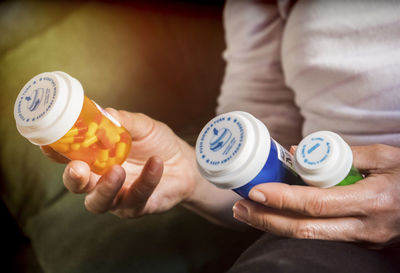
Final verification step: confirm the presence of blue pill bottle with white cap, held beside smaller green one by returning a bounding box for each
[196,111,305,199]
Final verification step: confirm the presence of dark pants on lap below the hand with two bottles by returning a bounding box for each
[228,234,400,273]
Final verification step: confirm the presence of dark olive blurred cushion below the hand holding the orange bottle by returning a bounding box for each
[28,193,260,273]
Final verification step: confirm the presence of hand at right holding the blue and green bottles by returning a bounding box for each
[233,145,400,245]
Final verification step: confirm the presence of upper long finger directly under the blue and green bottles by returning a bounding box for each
[249,181,381,217]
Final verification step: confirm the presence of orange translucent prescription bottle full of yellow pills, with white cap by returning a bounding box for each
[14,71,132,175]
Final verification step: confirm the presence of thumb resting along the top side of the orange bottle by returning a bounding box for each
[106,108,155,140]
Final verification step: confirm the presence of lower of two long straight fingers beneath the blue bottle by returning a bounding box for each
[233,200,364,241]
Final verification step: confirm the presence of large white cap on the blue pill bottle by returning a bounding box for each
[196,111,271,189]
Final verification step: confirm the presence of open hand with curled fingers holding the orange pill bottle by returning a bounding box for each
[42,108,197,218]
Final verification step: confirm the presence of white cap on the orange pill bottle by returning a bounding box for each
[14,71,84,145]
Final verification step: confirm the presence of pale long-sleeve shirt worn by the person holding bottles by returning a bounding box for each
[217,0,400,146]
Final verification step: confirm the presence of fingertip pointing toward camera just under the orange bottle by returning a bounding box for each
[63,160,99,193]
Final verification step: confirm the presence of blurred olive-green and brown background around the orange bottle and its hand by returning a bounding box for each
[0,1,260,272]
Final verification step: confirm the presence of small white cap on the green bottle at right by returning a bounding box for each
[294,131,353,188]
